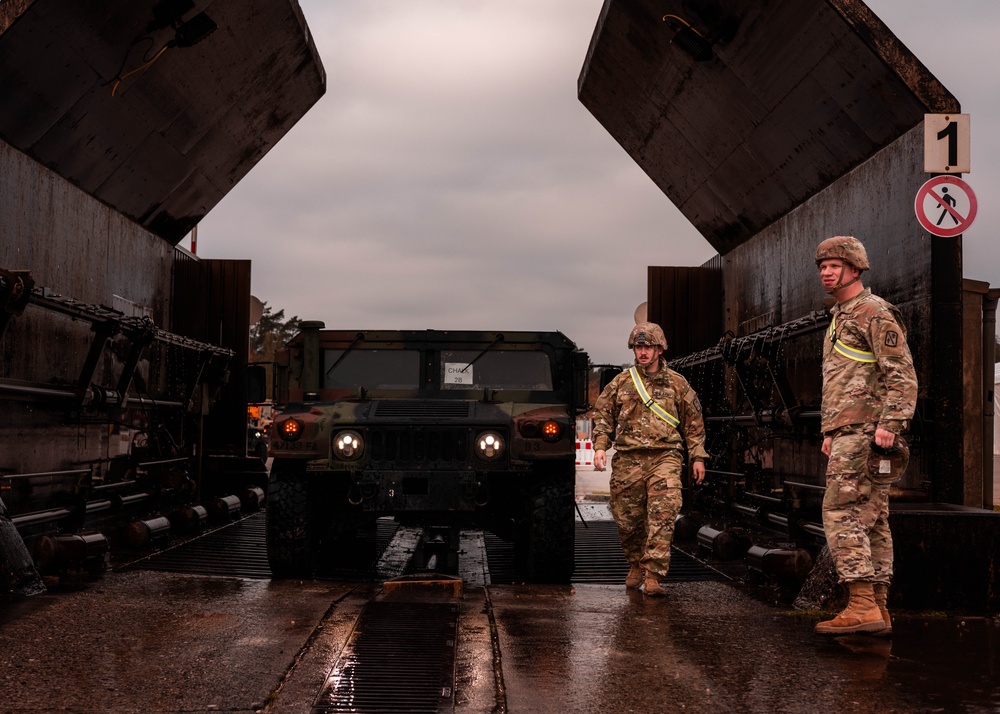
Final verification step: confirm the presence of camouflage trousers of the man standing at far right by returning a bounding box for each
[823,424,892,584]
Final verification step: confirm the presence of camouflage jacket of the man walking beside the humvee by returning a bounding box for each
[594,359,708,461]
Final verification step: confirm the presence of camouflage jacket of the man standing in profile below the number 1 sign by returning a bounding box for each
[821,288,917,434]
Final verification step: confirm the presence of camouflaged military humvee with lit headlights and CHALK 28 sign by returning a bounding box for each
[267,322,588,582]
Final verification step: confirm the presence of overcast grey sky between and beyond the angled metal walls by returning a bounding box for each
[189,0,1000,363]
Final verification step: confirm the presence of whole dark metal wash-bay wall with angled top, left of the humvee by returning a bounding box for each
[0,0,325,597]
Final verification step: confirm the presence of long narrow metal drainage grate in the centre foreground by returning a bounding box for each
[312,601,458,714]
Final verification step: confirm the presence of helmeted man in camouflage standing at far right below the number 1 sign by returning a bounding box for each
[816,236,917,634]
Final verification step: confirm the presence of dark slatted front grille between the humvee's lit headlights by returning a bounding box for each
[369,428,474,469]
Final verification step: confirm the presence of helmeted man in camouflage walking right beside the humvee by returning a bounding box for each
[594,322,708,596]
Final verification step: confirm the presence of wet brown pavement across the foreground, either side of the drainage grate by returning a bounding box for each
[0,464,1000,714]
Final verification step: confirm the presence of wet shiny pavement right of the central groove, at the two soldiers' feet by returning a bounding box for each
[492,583,1000,714]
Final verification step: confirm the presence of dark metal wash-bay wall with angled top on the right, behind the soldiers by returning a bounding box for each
[579,0,1000,610]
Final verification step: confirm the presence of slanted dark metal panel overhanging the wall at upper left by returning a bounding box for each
[0,0,325,244]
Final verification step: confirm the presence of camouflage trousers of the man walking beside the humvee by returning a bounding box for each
[611,449,683,577]
